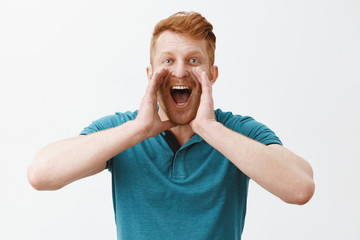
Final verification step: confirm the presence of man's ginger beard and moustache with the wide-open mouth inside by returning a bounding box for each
[158,77,201,125]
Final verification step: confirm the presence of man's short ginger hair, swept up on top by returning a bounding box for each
[150,12,216,66]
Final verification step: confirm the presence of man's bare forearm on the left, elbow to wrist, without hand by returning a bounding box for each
[28,121,146,190]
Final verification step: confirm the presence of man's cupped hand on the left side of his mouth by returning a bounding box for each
[135,68,175,138]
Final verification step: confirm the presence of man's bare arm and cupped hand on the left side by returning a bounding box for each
[28,70,173,190]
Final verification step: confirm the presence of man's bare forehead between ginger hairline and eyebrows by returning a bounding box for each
[154,31,207,57]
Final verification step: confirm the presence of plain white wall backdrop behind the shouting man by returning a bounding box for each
[0,0,360,240]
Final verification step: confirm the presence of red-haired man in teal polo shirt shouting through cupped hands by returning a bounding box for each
[28,12,314,240]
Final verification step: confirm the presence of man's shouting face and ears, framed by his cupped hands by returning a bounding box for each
[147,31,217,125]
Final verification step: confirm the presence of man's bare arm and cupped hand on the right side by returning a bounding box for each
[190,69,315,204]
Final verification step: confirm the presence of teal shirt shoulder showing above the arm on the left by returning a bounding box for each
[80,111,138,134]
